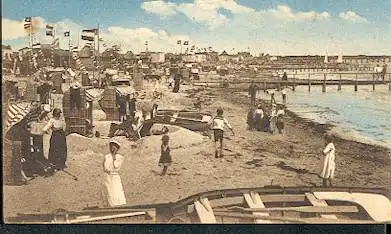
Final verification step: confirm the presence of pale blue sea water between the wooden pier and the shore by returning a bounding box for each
[257,85,391,148]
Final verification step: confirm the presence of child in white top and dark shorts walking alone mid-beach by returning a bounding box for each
[209,107,235,158]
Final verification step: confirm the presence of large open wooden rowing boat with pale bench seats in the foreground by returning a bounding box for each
[6,186,391,224]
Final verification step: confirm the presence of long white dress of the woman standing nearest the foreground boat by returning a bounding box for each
[103,154,126,207]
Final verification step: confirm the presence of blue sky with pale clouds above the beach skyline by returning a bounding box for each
[2,0,391,55]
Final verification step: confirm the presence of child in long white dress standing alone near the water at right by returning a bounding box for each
[320,135,335,187]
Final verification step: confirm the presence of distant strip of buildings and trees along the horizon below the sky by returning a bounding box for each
[2,45,391,73]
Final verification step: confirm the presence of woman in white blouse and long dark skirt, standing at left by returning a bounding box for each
[43,108,68,170]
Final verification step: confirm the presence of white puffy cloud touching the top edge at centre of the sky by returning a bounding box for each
[141,0,255,29]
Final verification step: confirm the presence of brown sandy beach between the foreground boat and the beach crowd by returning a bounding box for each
[3,83,391,218]
